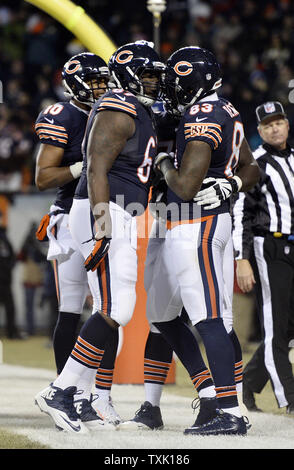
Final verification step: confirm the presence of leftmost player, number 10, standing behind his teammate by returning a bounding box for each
[35,53,118,428]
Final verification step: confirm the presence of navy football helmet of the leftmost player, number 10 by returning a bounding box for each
[62,52,110,106]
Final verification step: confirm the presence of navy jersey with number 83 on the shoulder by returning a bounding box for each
[167,94,244,220]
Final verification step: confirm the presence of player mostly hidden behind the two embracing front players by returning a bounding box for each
[120,96,248,430]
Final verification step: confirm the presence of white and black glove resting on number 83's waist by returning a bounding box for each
[193,176,242,210]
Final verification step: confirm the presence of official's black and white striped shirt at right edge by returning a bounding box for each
[232,144,294,259]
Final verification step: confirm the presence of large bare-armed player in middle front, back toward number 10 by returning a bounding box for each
[34,41,165,432]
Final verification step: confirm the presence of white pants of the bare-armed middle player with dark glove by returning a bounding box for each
[69,199,137,326]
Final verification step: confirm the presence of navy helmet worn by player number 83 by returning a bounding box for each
[163,46,222,112]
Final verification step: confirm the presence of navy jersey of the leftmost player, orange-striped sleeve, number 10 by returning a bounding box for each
[35,102,88,212]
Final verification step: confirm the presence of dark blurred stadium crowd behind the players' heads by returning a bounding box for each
[0,0,294,192]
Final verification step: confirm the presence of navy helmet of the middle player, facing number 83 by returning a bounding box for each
[108,41,165,106]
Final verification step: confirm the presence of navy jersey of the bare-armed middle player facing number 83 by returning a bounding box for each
[75,89,157,215]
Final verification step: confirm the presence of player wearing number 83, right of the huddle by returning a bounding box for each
[149,47,259,435]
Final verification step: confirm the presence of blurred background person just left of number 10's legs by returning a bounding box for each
[17,222,46,336]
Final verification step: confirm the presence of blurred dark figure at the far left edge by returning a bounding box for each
[0,209,21,339]
